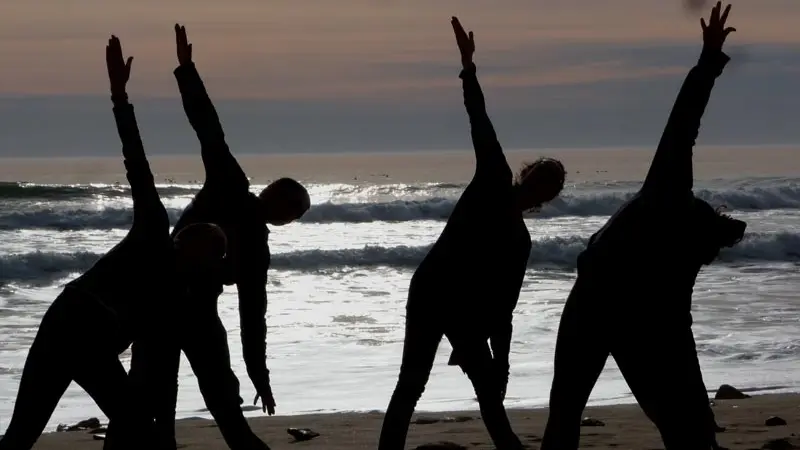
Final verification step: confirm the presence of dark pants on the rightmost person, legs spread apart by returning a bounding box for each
[541,276,715,450]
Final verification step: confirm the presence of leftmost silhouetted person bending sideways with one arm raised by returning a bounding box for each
[0,36,224,450]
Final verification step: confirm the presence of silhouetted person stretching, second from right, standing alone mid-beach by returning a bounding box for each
[379,17,565,450]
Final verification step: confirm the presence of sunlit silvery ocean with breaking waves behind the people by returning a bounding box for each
[0,171,800,430]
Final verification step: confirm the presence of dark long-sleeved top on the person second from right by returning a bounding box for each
[409,65,531,357]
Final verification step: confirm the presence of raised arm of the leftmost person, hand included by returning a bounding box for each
[106,36,169,230]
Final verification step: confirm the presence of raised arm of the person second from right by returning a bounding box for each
[451,17,508,175]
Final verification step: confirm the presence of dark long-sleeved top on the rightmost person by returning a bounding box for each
[578,50,729,307]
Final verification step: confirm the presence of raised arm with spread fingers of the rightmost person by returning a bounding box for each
[642,2,735,204]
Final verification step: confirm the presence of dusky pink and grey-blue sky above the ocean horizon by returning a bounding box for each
[0,0,800,156]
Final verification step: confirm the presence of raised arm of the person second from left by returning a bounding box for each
[174,24,250,189]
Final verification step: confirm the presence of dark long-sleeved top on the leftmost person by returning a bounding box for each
[67,97,174,352]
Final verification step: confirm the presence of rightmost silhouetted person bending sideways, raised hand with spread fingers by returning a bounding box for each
[542,3,746,450]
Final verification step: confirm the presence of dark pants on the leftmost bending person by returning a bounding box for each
[0,287,150,450]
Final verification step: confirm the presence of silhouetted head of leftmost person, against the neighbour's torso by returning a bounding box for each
[173,223,228,278]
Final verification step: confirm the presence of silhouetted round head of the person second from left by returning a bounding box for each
[258,178,311,225]
